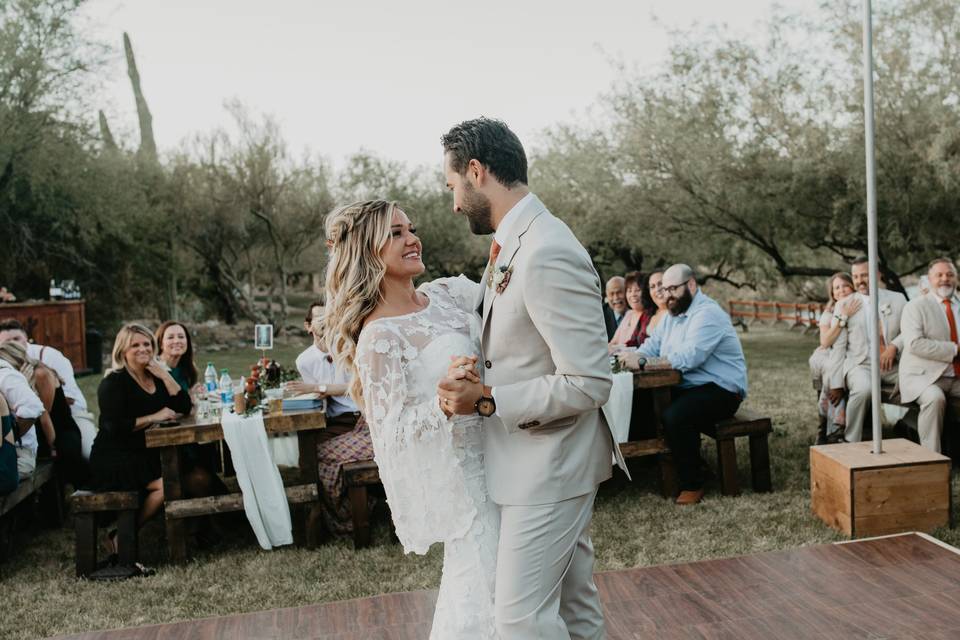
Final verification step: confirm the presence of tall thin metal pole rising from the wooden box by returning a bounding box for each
[863,0,883,454]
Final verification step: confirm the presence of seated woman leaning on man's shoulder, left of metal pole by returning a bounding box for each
[808,272,862,444]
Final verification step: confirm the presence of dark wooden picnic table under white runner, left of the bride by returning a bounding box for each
[144,409,326,562]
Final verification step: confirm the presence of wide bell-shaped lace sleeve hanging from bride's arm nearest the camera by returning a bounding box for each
[356,323,477,554]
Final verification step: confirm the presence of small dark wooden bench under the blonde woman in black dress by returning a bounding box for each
[70,491,140,578]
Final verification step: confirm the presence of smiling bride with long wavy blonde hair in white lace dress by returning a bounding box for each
[324,200,499,640]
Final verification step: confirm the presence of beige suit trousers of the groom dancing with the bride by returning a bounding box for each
[494,490,606,640]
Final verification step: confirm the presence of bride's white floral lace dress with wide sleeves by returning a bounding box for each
[356,276,500,640]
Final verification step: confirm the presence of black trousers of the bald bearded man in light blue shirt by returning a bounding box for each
[661,382,742,491]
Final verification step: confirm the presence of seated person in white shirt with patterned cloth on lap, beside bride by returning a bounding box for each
[287,302,373,534]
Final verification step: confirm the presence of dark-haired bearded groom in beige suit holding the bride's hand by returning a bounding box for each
[438,118,622,640]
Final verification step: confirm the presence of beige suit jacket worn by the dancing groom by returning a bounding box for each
[476,196,625,505]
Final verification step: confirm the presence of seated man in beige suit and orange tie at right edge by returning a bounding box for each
[900,258,960,452]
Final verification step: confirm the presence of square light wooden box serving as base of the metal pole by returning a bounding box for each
[810,438,950,537]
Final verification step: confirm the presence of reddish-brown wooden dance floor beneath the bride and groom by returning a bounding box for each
[60,534,960,640]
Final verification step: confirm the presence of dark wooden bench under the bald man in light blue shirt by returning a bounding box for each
[703,407,773,496]
